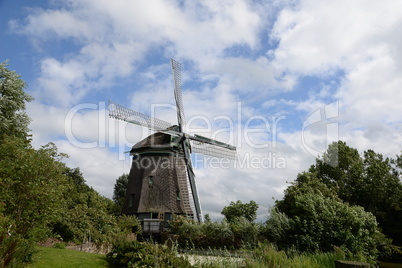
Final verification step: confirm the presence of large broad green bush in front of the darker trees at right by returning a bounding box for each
[265,174,378,260]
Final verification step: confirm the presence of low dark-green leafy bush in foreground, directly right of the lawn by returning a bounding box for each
[107,239,191,267]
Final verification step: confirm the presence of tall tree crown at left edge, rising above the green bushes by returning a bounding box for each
[0,62,32,141]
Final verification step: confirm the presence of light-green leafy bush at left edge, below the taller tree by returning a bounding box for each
[0,137,66,239]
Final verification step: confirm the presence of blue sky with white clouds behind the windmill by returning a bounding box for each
[0,0,402,220]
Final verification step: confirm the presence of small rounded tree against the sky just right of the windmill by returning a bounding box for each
[221,200,258,222]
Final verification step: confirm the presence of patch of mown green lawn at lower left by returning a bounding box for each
[27,247,108,268]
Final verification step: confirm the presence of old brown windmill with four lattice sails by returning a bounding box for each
[108,59,236,222]
